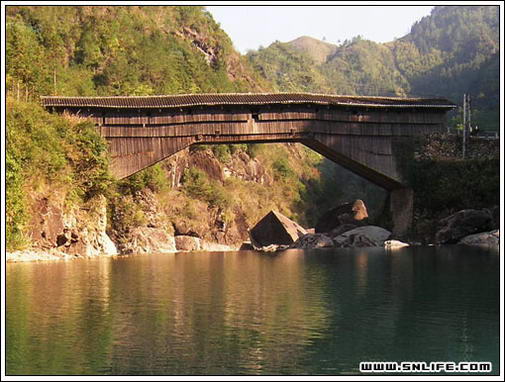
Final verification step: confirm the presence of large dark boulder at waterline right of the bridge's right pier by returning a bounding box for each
[435,209,493,244]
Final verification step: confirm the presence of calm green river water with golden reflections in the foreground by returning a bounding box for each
[6,246,500,375]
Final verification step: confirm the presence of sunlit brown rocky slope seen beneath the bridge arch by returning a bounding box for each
[109,144,328,252]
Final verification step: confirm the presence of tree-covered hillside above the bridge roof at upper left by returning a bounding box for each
[6,6,266,96]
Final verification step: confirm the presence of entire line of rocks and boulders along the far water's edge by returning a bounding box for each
[6,193,500,262]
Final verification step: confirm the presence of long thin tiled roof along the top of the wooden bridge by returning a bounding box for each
[41,93,456,109]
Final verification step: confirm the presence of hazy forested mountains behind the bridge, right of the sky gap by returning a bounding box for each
[248,6,499,130]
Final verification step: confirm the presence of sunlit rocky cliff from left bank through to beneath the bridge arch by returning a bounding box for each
[12,137,330,257]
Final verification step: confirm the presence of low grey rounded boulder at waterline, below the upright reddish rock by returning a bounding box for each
[333,225,391,248]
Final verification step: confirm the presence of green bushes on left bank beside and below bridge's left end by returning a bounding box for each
[6,98,111,250]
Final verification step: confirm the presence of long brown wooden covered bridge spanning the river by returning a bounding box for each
[42,93,455,236]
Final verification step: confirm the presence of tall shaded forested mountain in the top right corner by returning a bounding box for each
[392,6,500,112]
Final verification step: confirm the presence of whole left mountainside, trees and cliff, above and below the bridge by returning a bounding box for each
[6,6,336,252]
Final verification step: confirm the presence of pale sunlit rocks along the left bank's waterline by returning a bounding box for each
[6,184,239,263]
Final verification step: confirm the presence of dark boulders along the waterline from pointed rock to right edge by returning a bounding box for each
[246,200,500,252]
